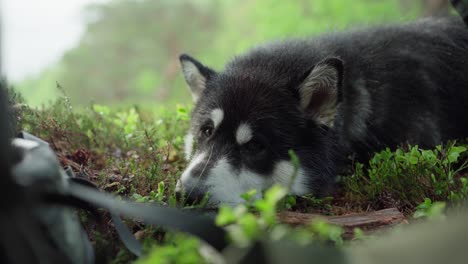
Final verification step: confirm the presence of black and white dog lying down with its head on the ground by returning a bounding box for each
[177,18,468,205]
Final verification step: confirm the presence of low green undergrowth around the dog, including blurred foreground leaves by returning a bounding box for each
[14,89,468,263]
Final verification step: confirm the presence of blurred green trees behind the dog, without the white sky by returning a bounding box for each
[15,0,445,106]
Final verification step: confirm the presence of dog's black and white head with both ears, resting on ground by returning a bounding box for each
[177,52,343,205]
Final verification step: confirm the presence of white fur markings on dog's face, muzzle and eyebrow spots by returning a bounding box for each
[181,108,308,205]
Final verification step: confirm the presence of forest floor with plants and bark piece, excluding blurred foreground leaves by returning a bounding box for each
[14,90,468,263]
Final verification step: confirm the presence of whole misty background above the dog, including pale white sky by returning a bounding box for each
[0,0,448,106]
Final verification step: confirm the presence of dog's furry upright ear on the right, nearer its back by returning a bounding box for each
[298,57,343,126]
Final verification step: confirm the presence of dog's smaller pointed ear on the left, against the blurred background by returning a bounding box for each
[179,54,215,102]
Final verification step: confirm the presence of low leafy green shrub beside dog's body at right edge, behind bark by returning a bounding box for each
[342,143,467,208]
